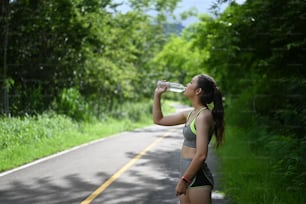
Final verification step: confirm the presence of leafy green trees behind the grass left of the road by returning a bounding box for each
[0,0,176,115]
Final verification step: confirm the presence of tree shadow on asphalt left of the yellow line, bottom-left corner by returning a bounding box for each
[0,174,96,204]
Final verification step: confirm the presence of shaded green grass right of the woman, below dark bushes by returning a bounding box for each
[217,127,306,204]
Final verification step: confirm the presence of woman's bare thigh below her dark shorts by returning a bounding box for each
[188,185,212,204]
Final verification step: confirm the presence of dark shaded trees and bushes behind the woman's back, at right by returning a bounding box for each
[194,0,306,203]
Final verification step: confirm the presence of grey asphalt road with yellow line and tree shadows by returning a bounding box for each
[0,110,225,204]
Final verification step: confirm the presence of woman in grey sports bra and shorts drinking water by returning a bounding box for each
[153,74,224,204]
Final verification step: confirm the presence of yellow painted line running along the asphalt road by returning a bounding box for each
[81,130,173,204]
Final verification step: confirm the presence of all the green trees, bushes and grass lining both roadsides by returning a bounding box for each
[0,0,306,204]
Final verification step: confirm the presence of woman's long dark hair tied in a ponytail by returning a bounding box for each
[197,74,225,147]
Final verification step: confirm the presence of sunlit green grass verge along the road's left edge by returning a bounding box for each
[0,101,173,172]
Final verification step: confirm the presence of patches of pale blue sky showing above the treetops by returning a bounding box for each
[115,0,245,26]
